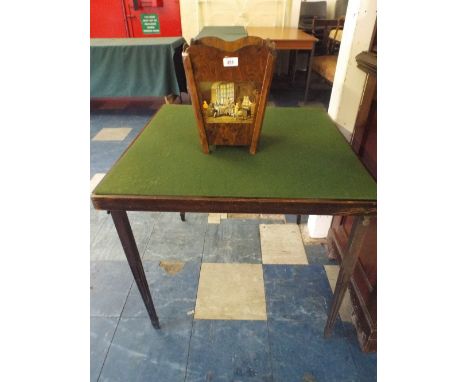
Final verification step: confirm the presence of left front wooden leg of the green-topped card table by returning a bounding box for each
[110,211,160,329]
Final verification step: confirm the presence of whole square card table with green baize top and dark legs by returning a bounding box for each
[91,105,377,336]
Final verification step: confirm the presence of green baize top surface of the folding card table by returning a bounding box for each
[94,105,377,200]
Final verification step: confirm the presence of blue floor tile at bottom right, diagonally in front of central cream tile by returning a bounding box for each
[268,319,361,382]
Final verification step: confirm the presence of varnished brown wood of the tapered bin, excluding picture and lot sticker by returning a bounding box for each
[183,36,276,154]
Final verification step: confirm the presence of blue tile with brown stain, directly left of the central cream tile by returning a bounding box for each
[122,261,200,325]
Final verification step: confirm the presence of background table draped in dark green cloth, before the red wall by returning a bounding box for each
[90,37,186,98]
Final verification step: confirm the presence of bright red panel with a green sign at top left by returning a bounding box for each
[90,0,182,38]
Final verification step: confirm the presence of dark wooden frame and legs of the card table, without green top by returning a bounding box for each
[91,106,377,336]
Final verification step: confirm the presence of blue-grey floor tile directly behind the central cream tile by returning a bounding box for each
[203,219,262,264]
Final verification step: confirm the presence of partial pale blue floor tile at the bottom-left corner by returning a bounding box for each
[90,317,119,382]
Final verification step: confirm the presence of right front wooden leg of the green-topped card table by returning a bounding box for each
[324,216,370,337]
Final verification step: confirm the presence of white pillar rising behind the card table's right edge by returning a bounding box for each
[328,0,377,140]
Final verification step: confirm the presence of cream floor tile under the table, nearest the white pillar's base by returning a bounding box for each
[260,224,308,264]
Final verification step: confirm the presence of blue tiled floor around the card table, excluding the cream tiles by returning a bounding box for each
[90,79,377,382]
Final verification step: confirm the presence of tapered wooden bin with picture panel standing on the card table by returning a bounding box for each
[182,36,276,154]
